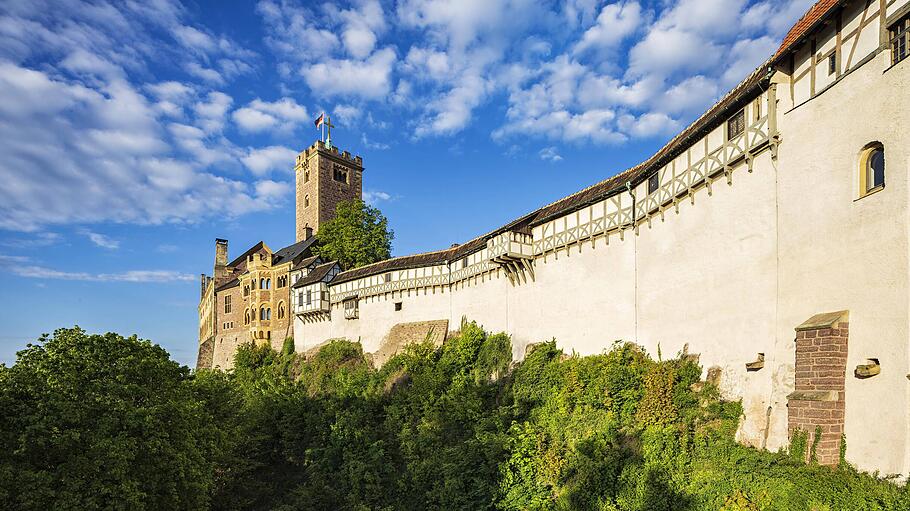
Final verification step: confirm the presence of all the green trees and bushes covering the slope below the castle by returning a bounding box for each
[0,323,910,511]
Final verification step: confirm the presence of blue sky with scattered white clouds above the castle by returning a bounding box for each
[0,0,811,365]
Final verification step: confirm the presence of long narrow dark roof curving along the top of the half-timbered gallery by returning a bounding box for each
[332,60,772,283]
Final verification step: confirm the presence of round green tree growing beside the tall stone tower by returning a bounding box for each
[316,199,395,270]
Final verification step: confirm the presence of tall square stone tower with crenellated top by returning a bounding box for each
[294,141,363,241]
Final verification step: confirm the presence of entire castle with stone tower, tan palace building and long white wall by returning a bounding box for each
[197,0,910,475]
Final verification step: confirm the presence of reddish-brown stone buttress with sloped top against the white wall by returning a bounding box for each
[787,311,849,465]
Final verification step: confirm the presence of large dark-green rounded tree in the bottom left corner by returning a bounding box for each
[0,327,225,510]
